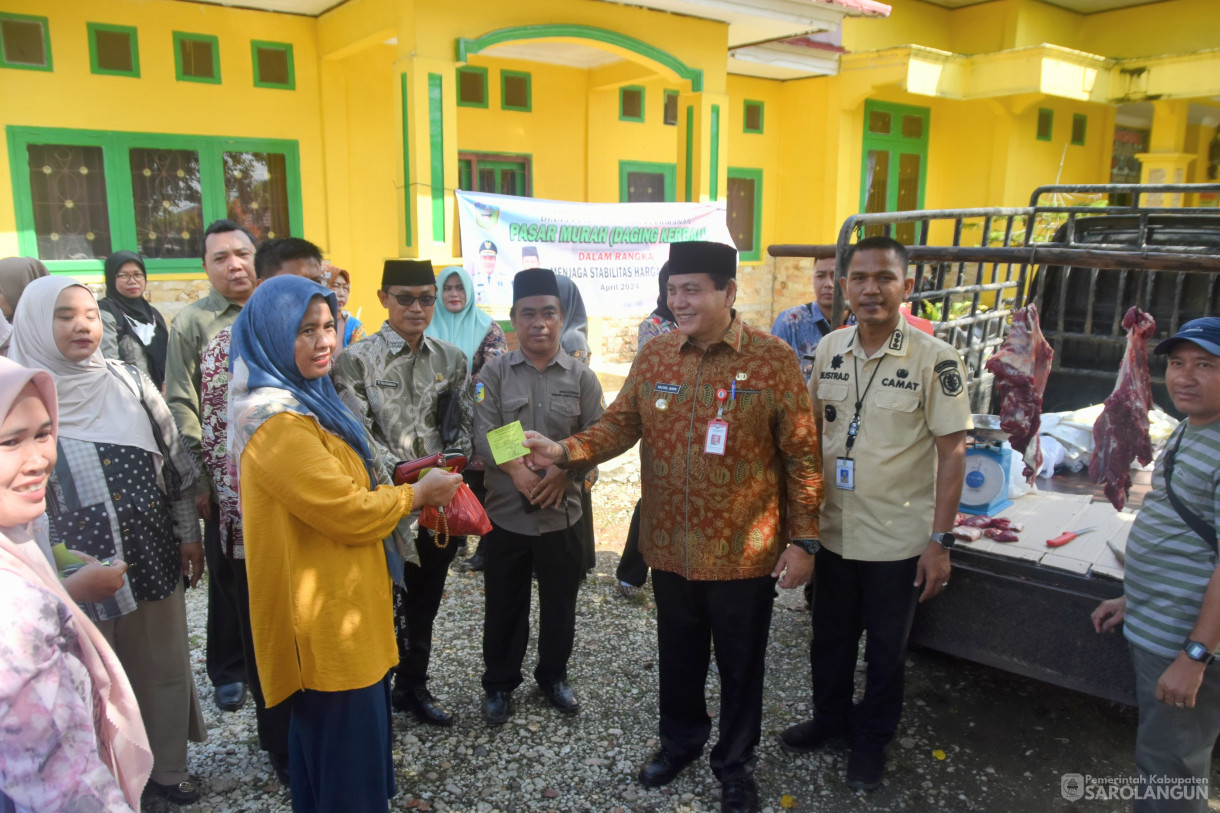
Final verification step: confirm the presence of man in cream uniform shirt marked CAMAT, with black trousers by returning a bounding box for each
[780,237,971,790]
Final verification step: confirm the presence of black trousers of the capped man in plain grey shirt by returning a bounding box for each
[481,522,584,691]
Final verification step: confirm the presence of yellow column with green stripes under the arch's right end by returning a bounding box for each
[675,93,728,203]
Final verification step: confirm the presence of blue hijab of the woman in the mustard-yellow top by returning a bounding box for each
[229,275,377,476]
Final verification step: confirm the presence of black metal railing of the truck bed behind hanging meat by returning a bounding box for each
[767,183,1220,411]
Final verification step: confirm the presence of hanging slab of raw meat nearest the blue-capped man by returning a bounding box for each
[1088,308,1157,510]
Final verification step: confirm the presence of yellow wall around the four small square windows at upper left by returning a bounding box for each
[0,0,328,276]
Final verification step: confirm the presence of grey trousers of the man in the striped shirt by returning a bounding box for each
[1131,646,1220,813]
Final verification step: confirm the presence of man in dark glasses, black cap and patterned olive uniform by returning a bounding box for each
[334,260,473,725]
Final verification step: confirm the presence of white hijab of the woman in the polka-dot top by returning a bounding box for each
[9,277,161,457]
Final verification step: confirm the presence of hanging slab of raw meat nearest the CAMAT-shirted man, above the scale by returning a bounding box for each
[987,305,1055,483]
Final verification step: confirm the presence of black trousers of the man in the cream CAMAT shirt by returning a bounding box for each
[809,548,919,751]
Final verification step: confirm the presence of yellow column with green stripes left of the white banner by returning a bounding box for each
[395,56,460,259]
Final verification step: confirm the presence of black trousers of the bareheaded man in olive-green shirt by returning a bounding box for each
[204,507,249,686]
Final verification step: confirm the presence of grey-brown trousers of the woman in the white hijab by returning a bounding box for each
[98,584,207,785]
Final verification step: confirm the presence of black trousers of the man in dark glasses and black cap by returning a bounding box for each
[394,526,460,692]
